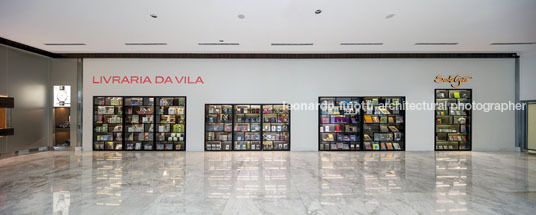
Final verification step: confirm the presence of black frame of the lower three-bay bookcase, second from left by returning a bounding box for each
[203,103,292,152]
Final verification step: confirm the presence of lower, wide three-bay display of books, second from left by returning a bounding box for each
[205,104,290,151]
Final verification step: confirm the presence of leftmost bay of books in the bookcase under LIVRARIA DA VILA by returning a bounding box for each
[93,97,123,151]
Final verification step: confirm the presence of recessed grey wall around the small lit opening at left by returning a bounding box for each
[49,59,78,146]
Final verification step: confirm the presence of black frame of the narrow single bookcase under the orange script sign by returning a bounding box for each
[434,88,473,151]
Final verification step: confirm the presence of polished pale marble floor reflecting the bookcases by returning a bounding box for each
[0,151,536,215]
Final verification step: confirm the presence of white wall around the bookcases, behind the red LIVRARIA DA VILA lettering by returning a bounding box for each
[83,59,515,151]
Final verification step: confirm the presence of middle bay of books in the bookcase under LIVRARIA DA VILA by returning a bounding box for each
[124,97,154,151]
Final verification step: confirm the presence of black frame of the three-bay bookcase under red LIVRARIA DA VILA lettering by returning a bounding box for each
[92,96,188,152]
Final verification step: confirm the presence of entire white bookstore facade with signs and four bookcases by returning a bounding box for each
[82,58,515,151]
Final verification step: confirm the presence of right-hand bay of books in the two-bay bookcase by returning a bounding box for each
[362,97,406,151]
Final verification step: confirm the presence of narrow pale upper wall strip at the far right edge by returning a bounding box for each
[519,51,536,100]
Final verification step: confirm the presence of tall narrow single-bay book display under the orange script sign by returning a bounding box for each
[435,89,472,151]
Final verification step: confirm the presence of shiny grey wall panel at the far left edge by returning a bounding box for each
[0,45,51,154]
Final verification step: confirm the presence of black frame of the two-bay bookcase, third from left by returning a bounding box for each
[317,96,407,152]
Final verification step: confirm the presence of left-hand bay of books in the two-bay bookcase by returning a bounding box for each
[318,97,361,151]
